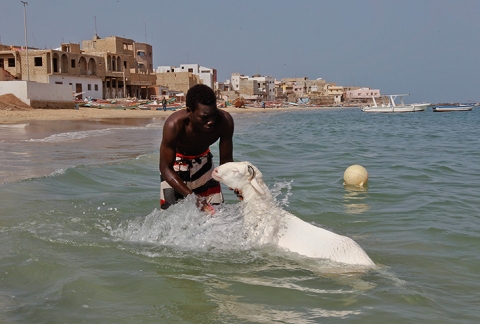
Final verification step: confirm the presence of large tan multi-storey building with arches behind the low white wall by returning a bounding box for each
[0,36,156,98]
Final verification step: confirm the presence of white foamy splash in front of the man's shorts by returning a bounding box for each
[112,196,250,251]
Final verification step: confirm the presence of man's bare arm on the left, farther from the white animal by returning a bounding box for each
[159,121,192,197]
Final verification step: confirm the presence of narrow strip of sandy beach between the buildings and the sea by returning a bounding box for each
[0,106,352,125]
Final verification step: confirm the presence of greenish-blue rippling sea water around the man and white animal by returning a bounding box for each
[0,108,480,323]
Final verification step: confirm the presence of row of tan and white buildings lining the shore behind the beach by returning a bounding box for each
[0,35,380,108]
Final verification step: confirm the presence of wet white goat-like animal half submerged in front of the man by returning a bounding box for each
[212,162,375,266]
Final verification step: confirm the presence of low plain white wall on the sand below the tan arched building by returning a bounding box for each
[0,81,74,108]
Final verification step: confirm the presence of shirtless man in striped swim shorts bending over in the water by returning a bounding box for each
[160,84,237,211]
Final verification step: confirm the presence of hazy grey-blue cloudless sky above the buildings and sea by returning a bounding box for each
[0,0,480,103]
